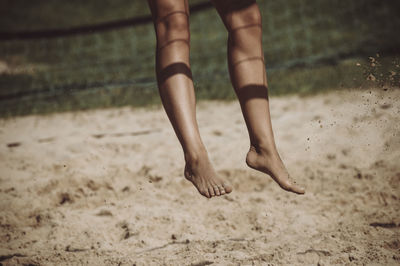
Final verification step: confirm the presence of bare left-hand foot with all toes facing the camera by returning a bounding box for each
[185,152,232,198]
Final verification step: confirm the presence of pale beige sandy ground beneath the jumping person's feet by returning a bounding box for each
[0,89,400,265]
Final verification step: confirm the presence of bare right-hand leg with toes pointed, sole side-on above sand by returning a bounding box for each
[213,0,305,194]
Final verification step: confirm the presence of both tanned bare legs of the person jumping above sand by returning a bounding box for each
[148,0,305,198]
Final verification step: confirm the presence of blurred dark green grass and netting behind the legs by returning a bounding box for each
[0,0,400,117]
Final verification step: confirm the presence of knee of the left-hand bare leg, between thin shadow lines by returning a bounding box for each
[156,11,190,41]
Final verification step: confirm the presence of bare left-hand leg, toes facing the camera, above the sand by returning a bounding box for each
[148,0,232,198]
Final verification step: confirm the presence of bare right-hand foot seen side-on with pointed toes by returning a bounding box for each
[246,146,305,194]
